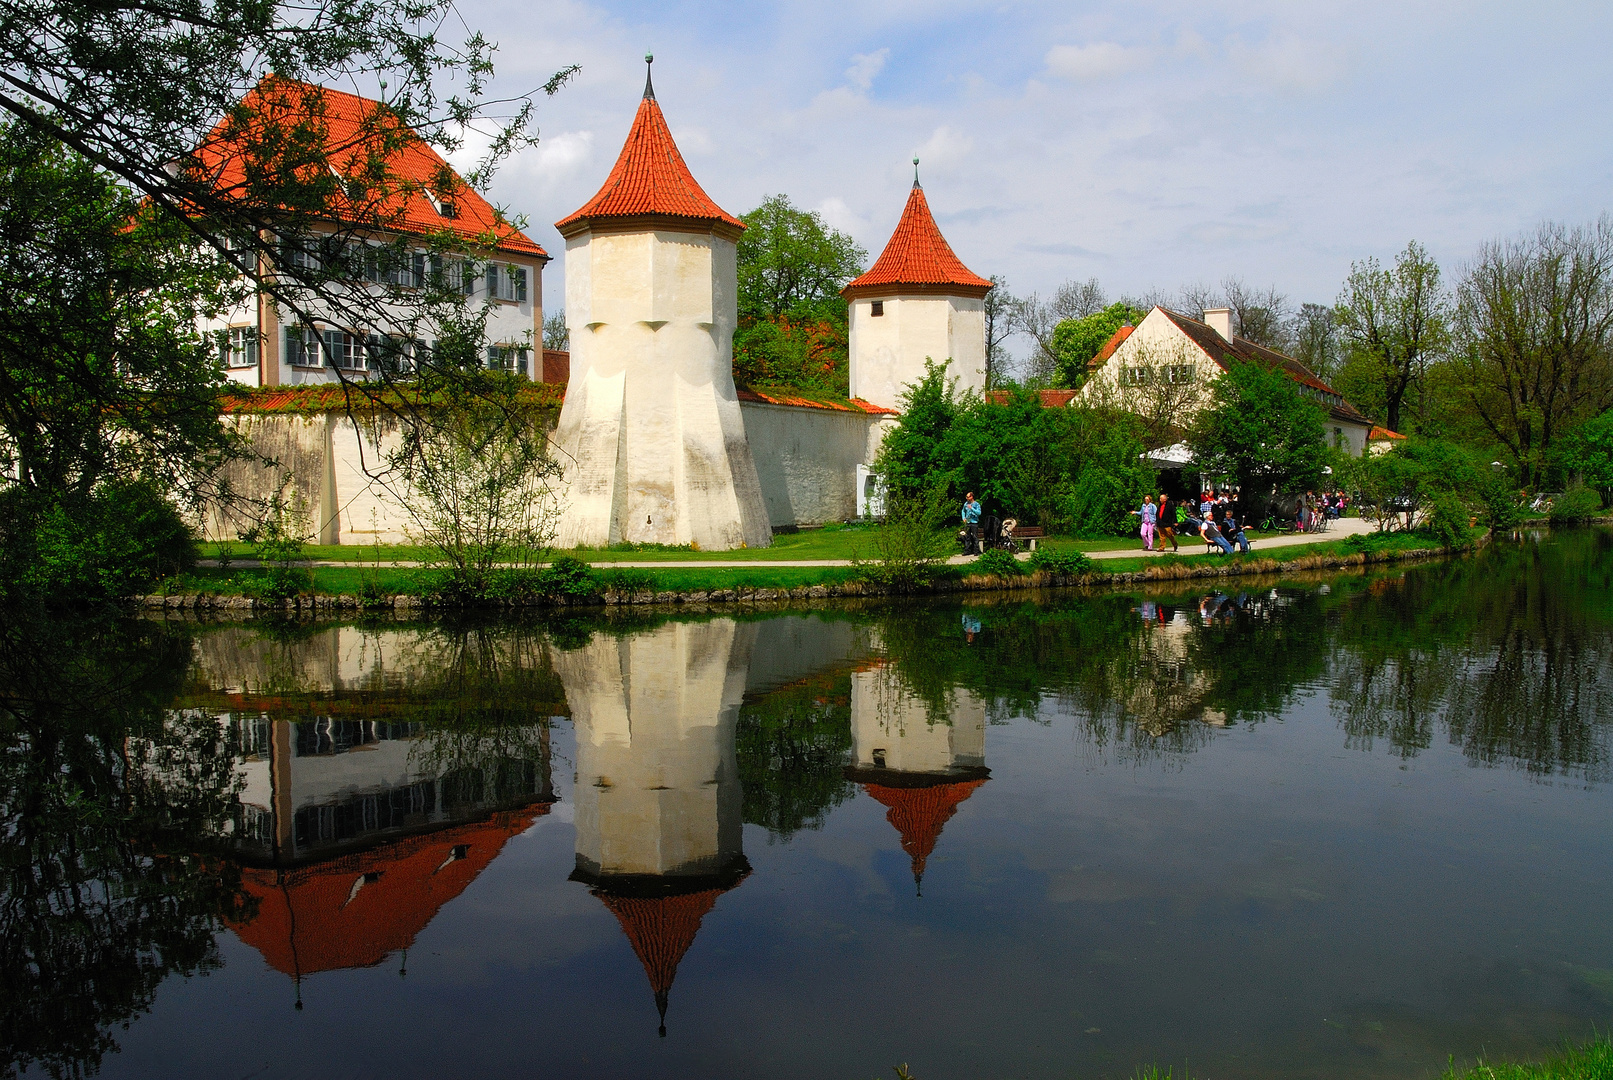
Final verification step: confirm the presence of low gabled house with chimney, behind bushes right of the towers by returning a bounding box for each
[1077,306,1373,456]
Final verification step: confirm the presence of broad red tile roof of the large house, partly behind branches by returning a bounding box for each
[195,74,548,260]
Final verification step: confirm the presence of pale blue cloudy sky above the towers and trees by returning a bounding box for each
[425,0,1613,346]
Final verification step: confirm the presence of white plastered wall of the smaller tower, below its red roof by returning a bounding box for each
[848,295,986,409]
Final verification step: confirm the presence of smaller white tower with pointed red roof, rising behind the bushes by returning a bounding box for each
[840,158,992,409]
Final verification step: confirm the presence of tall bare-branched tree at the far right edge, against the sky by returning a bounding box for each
[1455,216,1613,487]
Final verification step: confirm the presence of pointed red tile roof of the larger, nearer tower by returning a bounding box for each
[555,69,745,239]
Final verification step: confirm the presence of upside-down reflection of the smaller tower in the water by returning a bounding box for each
[845,663,990,895]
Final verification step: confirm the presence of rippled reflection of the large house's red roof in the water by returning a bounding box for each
[232,803,548,978]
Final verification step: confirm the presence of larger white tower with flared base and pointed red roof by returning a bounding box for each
[553,59,773,551]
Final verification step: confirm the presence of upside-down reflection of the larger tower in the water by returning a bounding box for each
[553,619,756,1035]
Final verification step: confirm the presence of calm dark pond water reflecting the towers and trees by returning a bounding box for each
[0,530,1613,1080]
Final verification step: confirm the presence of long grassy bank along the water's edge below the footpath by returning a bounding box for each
[139,530,1487,614]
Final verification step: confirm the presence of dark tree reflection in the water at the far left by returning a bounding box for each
[0,614,244,1077]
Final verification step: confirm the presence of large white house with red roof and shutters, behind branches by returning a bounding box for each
[195,76,550,387]
